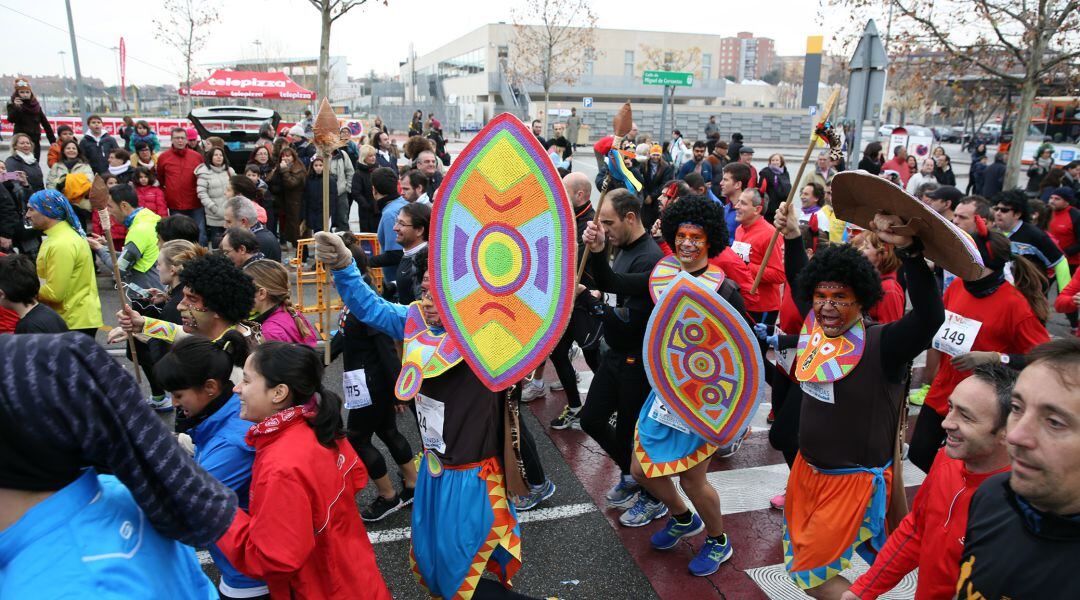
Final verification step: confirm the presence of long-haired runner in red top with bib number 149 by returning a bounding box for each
[908,224,1050,473]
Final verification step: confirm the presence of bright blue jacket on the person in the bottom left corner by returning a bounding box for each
[0,468,218,600]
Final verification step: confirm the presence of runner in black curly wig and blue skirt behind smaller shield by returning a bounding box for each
[582,196,764,576]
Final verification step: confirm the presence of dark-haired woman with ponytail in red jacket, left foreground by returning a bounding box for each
[217,342,390,600]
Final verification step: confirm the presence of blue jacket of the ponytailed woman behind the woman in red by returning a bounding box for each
[188,394,269,596]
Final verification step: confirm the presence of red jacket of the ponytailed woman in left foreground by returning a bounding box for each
[217,410,390,600]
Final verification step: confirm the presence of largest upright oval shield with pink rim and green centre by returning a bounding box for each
[428,113,577,391]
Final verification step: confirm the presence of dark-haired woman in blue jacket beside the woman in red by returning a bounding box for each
[153,331,270,600]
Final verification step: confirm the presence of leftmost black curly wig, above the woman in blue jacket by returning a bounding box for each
[180,255,255,323]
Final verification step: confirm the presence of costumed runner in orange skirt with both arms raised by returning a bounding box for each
[775,200,944,598]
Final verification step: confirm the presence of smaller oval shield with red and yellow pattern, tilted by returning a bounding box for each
[643,272,765,446]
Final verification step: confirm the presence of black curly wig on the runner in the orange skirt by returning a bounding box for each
[796,244,885,311]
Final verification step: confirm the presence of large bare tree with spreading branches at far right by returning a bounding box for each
[823,0,1080,188]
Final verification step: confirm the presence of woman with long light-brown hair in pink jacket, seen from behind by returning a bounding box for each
[244,259,315,347]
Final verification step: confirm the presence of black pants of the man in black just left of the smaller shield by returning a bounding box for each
[578,350,650,475]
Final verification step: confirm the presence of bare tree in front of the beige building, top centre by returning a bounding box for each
[510,0,596,132]
